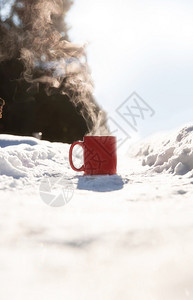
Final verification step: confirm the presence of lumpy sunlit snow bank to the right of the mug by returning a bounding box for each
[128,124,193,175]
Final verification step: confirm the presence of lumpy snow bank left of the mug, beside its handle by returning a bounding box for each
[0,135,69,182]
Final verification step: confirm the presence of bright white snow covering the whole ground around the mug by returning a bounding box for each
[0,125,193,300]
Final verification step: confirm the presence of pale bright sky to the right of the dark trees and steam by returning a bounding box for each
[67,0,193,142]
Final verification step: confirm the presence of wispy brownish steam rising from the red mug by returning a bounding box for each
[0,0,109,135]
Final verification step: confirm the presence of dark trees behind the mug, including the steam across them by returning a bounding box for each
[0,0,107,143]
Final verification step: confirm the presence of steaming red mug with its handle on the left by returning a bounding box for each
[69,136,117,175]
